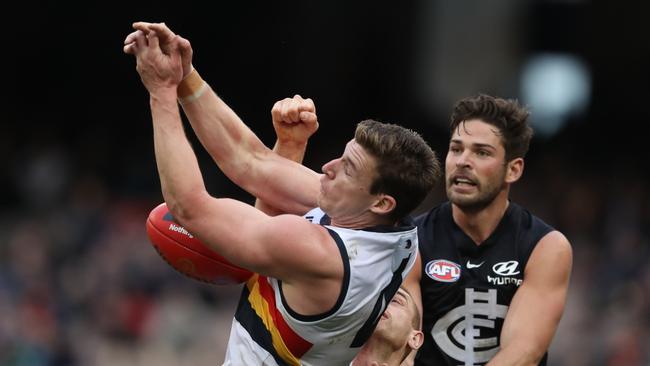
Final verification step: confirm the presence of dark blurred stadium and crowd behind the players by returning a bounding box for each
[0,0,650,366]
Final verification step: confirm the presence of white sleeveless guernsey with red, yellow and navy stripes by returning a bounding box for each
[224,208,418,366]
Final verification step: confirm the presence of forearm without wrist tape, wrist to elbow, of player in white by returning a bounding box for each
[150,93,205,223]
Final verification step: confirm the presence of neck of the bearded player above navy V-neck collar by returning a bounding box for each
[452,190,510,245]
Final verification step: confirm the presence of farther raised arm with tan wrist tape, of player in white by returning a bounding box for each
[128,23,320,214]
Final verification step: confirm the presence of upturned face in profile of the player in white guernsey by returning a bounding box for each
[318,140,376,222]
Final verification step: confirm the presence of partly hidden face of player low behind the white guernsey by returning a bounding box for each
[373,288,417,347]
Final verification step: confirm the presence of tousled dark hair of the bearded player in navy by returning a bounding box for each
[449,94,533,161]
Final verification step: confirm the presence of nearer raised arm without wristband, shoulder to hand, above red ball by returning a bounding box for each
[125,26,343,313]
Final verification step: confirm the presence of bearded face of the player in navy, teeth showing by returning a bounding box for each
[445,119,506,209]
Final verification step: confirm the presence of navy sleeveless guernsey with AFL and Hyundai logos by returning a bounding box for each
[415,202,554,366]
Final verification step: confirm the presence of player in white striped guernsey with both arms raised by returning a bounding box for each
[124,23,440,365]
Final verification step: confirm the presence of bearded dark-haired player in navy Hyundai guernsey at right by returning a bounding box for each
[405,95,572,366]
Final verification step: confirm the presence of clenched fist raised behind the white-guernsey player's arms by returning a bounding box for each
[271,94,318,144]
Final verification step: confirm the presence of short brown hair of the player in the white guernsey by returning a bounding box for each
[354,120,441,220]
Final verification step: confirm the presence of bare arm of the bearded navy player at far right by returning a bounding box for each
[488,231,573,366]
